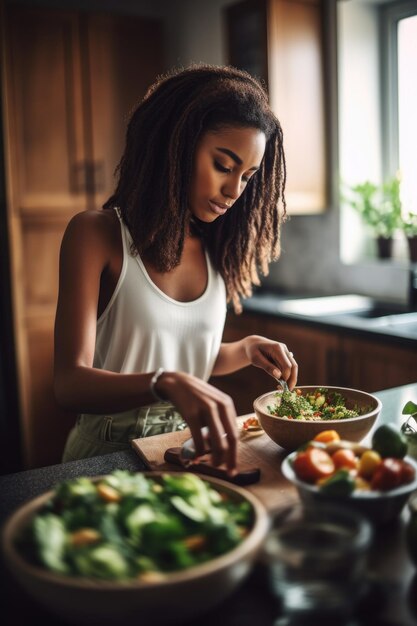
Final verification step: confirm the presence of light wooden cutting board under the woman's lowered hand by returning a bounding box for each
[132,414,298,511]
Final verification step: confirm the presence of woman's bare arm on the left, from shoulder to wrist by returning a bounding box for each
[54,211,153,413]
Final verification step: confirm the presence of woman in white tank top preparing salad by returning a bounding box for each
[55,65,297,472]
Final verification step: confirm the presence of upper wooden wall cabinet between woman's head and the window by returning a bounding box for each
[226,0,331,214]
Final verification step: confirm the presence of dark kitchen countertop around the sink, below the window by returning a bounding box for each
[243,290,417,348]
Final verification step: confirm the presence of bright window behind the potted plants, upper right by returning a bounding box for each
[337,0,417,263]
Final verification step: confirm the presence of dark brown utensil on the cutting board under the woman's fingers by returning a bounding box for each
[164,447,261,486]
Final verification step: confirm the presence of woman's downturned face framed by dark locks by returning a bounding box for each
[189,126,266,222]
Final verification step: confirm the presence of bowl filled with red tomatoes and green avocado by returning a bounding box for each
[281,424,417,524]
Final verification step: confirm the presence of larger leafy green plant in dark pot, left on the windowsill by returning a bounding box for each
[346,178,401,258]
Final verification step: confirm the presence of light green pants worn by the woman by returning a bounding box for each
[62,403,187,463]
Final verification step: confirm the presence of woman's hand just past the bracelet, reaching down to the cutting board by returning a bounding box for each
[155,372,237,473]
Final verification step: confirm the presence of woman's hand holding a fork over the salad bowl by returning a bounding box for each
[244,335,298,390]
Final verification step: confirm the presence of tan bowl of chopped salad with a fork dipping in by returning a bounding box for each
[253,385,382,451]
